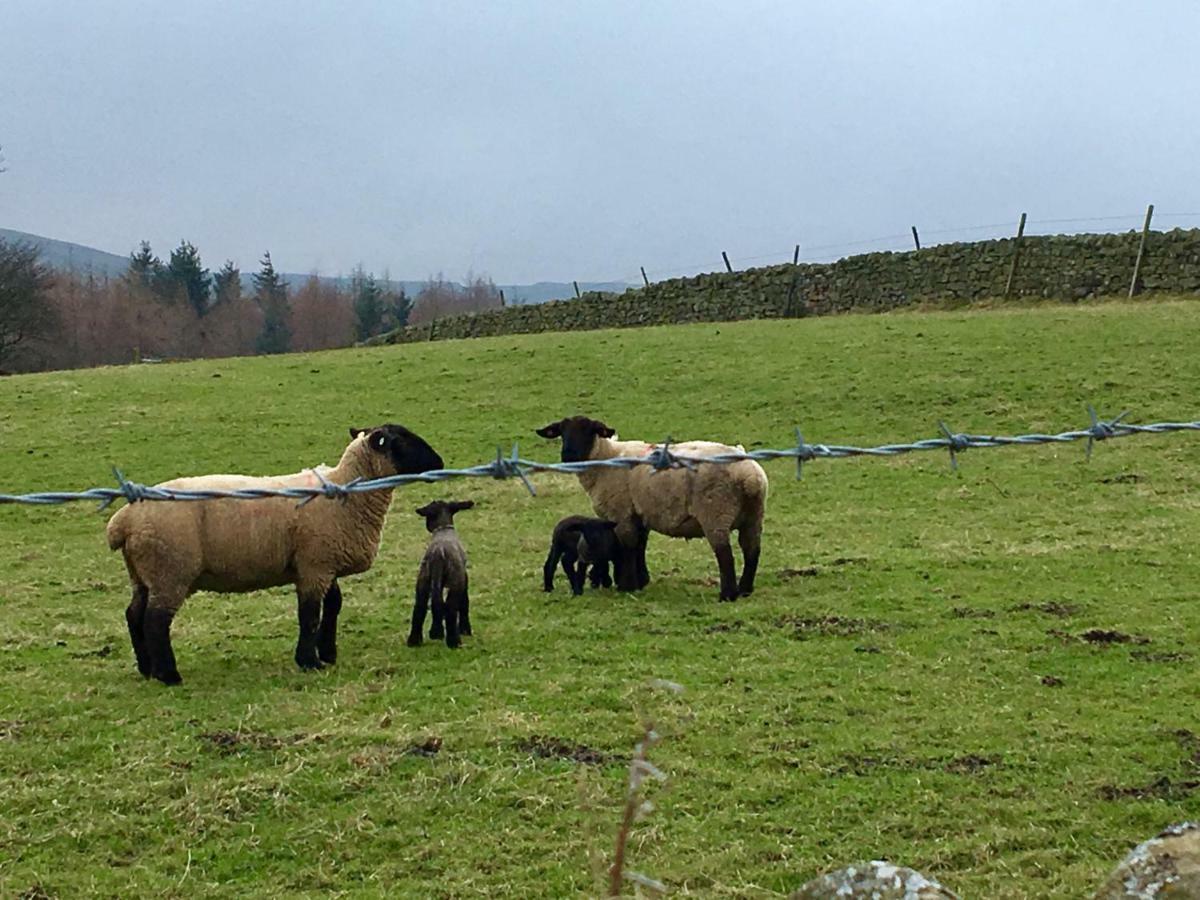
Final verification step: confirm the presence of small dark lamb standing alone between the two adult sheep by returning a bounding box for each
[408,500,475,649]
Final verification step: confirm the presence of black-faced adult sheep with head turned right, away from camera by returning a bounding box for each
[108,425,443,684]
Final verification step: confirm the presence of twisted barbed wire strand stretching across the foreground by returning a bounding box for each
[0,407,1200,509]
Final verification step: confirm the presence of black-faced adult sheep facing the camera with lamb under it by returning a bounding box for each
[536,415,767,601]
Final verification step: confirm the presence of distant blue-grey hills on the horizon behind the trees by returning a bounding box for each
[0,228,629,306]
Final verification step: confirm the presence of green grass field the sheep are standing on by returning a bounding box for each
[0,300,1200,898]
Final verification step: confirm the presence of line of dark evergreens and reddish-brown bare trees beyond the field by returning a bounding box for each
[0,240,502,371]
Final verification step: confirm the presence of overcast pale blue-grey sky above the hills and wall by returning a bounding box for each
[0,0,1200,282]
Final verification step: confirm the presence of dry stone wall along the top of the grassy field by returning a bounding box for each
[370,228,1200,343]
